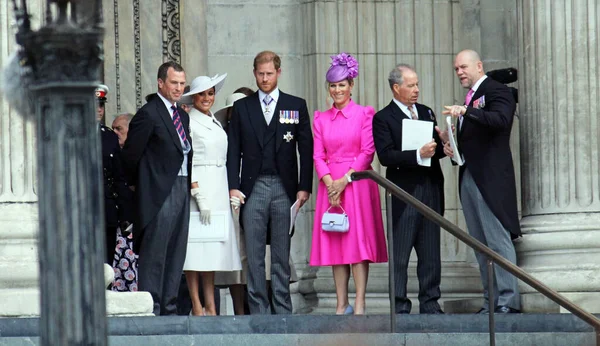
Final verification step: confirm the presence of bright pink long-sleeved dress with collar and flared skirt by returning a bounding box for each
[310,100,388,266]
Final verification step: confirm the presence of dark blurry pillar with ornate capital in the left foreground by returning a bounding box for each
[15,0,107,346]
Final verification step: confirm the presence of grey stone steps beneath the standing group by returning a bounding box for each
[0,314,595,346]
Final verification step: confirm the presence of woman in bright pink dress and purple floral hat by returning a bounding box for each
[310,53,387,315]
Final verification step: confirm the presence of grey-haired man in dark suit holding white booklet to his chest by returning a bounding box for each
[373,64,445,314]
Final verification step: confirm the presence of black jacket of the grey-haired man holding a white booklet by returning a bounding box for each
[373,100,445,218]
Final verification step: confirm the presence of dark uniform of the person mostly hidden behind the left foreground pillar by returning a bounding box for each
[99,125,133,265]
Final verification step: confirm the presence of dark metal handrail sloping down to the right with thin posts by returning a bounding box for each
[352,171,600,346]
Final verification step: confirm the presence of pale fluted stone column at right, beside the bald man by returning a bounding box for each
[517,0,600,313]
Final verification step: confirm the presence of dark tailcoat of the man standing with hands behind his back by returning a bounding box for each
[121,97,193,244]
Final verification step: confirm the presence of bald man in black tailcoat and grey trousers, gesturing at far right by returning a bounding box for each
[444,50,521,313]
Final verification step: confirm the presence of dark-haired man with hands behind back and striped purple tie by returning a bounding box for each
[122,62,192,315]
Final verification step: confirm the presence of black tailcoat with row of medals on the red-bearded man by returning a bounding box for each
[227,91,313,202]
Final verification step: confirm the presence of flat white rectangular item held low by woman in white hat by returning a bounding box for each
[188,211,230,243]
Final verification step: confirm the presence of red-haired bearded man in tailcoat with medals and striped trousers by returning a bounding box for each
[227,51,313,314]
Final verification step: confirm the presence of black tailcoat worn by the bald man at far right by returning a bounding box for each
[458,77,521,238]
